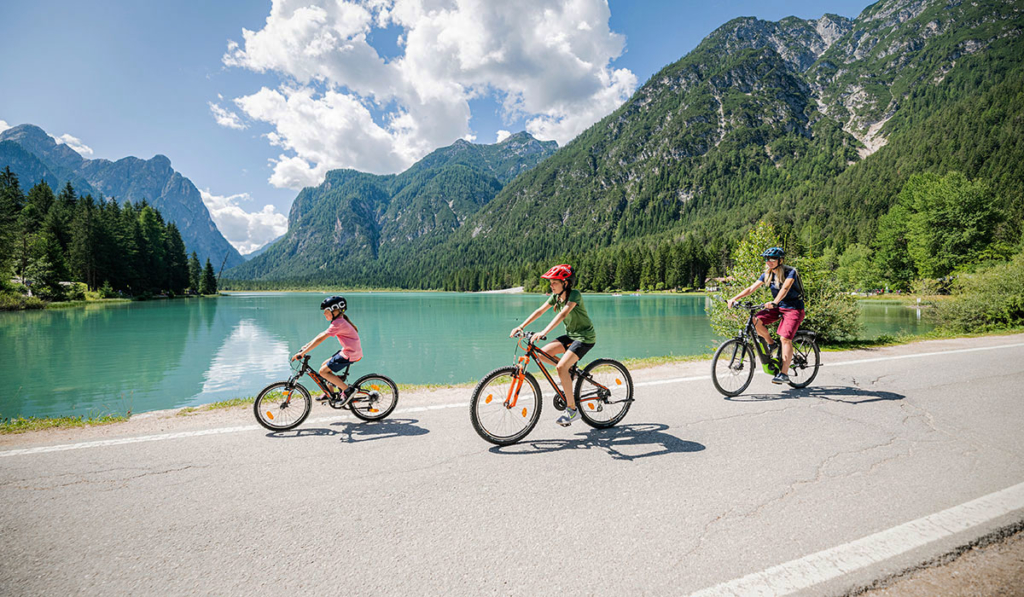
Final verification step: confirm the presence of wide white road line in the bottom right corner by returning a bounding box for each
[690,483,1024,597]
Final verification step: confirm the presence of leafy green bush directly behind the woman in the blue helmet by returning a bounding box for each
[709,221,860,343]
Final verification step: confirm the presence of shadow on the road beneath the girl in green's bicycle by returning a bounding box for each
[490,423,705,461]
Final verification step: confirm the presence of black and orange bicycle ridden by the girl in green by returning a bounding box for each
[469,332,633,445]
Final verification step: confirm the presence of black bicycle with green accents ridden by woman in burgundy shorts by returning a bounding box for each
[711,303,821,396]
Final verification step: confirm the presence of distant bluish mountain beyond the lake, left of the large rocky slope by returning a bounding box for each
[225,133,557,286]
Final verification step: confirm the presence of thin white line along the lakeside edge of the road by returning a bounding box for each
[0,342,1024,458]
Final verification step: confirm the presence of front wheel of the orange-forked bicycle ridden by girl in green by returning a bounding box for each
[469,367,541,445]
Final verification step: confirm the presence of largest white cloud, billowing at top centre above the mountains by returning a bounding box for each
[222,0,636,188]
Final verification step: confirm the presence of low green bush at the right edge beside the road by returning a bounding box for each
[935,247,1024,333]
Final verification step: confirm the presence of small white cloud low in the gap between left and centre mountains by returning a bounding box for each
[200,188,288,255]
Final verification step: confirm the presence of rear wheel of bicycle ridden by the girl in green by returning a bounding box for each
[573,358,633,429]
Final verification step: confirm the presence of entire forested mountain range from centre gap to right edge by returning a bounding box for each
[229,0,1024,288]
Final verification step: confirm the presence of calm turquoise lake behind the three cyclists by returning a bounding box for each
[0,293,932,418]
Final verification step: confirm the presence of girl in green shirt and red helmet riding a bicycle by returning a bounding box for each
[509,264,597,427]
